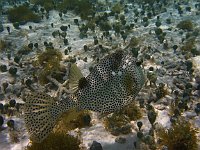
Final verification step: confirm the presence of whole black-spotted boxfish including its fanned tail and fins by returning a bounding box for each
[24,51,145,142]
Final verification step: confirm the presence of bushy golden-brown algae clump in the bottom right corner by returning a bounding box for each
[157,118,198,150]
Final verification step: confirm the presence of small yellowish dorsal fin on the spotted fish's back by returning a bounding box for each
[69,64,83,93]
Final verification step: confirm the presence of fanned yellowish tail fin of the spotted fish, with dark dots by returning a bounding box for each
[24,92,69,143]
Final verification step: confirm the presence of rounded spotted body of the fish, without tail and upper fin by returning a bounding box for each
[74,51,144,113]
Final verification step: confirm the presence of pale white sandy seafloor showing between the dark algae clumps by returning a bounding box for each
[0,0,200,150]
